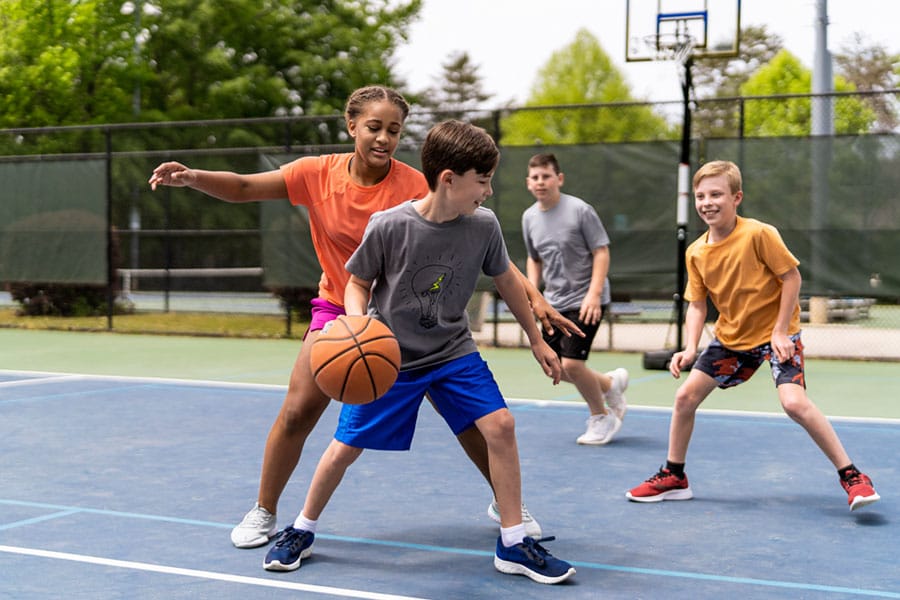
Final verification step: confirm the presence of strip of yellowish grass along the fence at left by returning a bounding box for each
[0,308,308,339]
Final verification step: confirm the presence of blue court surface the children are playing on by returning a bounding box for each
[0,371,900,600]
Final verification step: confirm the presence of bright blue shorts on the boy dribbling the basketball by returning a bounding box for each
[334,352,506,450]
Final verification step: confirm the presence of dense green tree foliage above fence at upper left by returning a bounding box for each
[0,0,422,127]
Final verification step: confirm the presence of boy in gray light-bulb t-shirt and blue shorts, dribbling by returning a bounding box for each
[266,121,575,583]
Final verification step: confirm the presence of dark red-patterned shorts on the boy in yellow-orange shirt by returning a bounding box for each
[692,333,806,388]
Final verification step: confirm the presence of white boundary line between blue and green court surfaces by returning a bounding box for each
[0,369,900,425]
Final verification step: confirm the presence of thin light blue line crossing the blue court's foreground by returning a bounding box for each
[0,499,900,599]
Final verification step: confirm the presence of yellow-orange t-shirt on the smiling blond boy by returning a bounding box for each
[684,217,800,350]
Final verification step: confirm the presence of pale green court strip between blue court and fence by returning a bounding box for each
[0,329,900,419]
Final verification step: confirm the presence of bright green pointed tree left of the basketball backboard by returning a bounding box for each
[501,29,673,145]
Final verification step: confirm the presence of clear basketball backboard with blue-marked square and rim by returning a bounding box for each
[625,0,741,62]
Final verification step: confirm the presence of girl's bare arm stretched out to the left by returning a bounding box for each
[149,161,288,202]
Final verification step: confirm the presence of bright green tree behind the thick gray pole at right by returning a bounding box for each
[741,50,875,137]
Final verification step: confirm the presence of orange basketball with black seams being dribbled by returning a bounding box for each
[309,315,400,404]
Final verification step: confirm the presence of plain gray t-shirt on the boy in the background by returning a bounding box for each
[522,194,610,312]
